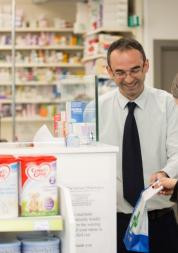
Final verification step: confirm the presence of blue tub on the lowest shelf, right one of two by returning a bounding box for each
[22,237,61,253]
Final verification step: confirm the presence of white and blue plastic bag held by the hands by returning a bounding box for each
[124,186,162,252]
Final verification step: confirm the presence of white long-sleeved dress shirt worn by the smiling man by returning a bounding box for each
[99,87,178,213]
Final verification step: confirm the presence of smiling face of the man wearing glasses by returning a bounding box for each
[107,49,149,100]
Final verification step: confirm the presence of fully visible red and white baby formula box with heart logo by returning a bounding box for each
[19,156,58,216]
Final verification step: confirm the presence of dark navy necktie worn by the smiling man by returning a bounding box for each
[122,102,144,206]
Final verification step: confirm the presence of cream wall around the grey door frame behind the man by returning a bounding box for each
[144,0,178,86]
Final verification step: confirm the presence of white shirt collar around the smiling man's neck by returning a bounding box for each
[118,86,148,110]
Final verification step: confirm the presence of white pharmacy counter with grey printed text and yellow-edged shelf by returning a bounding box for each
[0,143,118,253]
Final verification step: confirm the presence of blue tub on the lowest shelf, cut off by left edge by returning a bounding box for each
[0,240,21,253]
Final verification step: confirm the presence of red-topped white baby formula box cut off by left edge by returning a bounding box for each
[0,155,19,218]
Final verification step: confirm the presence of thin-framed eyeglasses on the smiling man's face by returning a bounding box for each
[111,65,144,79]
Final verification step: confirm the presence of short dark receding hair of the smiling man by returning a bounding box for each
[107,38,146,66]
